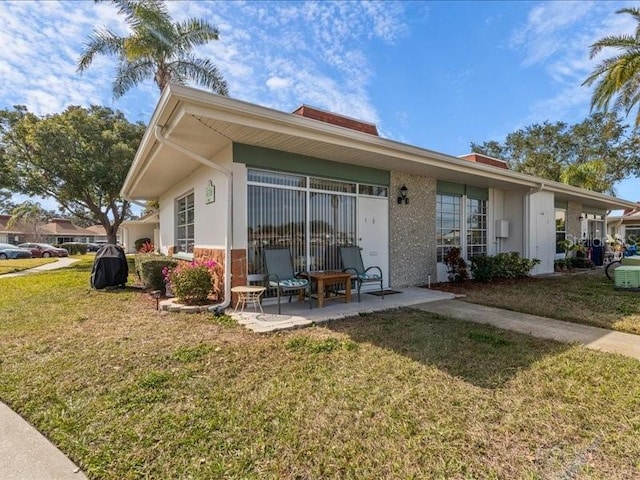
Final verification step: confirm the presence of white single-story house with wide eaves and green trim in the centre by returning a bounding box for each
[121,85,634,301]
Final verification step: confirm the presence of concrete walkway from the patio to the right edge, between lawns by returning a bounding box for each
[413,300,640,360]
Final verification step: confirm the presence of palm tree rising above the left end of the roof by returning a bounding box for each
[78,0,228,98]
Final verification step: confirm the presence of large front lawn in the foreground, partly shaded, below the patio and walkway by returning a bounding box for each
[0,262,640,479]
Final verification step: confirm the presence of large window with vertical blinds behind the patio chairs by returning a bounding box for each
[247,169,387,274]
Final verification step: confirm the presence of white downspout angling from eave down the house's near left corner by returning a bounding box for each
[153,125,233,312]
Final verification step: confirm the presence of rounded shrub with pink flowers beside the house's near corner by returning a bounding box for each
[162,260,218,305]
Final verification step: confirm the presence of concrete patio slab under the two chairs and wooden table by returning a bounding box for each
[227,287,455,333]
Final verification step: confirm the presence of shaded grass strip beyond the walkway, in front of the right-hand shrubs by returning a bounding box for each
[430,269,640,335]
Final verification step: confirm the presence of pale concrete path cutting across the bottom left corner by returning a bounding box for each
[0,402,87,480]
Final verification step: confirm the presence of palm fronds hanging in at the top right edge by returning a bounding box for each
[582,8,640,127]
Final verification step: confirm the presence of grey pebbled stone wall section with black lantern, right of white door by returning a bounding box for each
[389,172,437,288]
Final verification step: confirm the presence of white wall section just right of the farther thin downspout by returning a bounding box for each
[525,192,556,274]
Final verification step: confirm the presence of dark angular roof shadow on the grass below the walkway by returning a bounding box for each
[327,308,571,388]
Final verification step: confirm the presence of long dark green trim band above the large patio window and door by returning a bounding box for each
[233,143,391,187]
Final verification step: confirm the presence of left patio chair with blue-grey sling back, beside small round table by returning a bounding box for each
[263,248,313,315]
